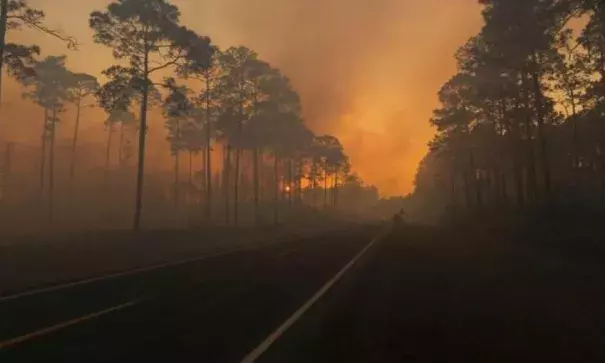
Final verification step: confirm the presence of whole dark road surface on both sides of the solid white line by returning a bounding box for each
[0,227,605,363]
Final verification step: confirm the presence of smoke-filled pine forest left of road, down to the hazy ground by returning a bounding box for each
[0,0,379,230]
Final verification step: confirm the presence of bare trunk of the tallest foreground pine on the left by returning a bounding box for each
[134,66,149,232]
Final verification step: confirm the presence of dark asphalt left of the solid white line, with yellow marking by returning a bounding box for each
[0,227,378,363]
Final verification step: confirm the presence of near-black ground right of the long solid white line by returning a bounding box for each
[257,228,605,363]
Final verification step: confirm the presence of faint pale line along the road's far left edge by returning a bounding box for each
[0,246,263,303]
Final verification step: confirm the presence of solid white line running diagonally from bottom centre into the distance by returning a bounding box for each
[241,230,382,363]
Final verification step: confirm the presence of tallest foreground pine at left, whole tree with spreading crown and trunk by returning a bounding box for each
[90,0,213,230]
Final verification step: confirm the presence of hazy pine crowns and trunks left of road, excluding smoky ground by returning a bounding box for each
[0,0,378,230]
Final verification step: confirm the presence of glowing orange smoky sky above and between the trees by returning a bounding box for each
[1,0,481,195]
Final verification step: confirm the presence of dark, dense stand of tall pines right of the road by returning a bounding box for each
[416,0,605,219]
